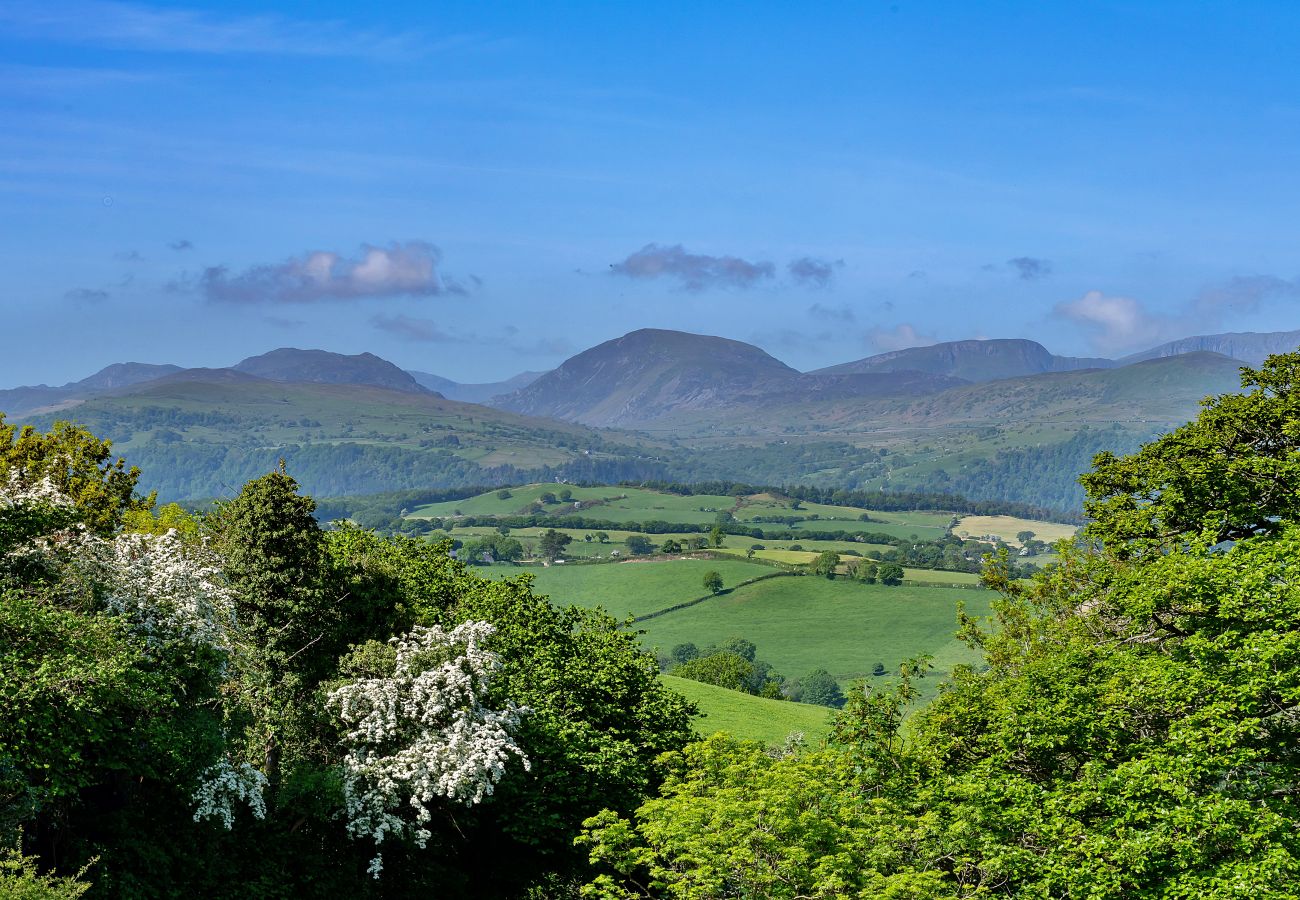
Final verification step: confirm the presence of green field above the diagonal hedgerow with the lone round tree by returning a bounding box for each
[478,559,775,618]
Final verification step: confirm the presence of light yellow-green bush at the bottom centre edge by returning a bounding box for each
[582,735,958,900]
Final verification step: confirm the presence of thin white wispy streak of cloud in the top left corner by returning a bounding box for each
[0,0,426,57]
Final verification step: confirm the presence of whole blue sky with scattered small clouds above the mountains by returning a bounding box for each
[0,0,1300,386]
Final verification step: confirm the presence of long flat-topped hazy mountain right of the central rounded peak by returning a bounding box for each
[810,338,1115,381]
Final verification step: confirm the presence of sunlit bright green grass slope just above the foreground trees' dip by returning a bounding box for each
[660,675,832,747]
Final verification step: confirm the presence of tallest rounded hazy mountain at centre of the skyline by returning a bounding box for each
[497,328,802,427]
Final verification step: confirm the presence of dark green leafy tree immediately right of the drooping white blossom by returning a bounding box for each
[447,569,694,877]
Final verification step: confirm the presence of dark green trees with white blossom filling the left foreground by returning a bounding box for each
[0,423,692,897]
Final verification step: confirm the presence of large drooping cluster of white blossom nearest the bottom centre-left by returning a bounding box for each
[328,622,529,878]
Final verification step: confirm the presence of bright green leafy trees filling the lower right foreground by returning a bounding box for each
[584,355,1300,899]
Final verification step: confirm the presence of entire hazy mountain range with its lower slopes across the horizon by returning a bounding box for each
[0,329,1300,510]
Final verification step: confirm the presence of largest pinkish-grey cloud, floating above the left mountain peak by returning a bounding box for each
[196,241,464,303]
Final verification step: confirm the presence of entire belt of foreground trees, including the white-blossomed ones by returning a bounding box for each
[0,354,1300,900]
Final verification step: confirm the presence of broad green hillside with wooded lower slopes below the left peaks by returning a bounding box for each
[19,380,657,499]
